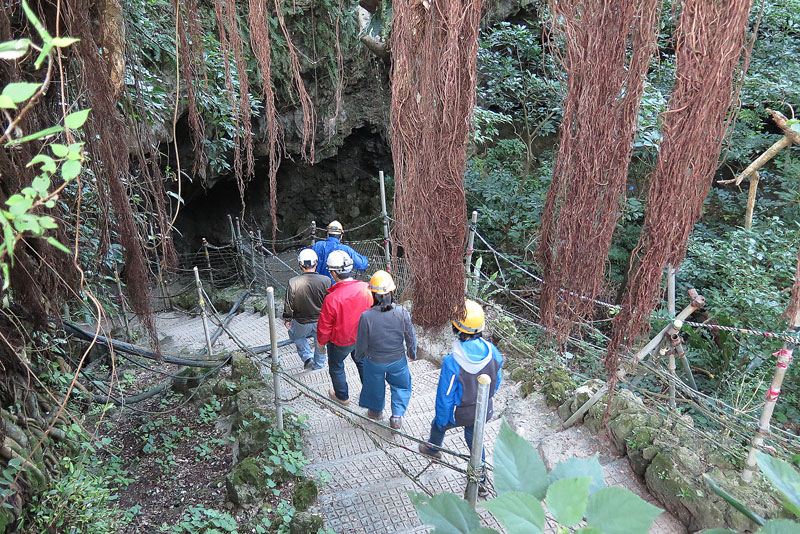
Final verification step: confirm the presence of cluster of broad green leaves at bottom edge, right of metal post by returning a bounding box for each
[411,422,661,534]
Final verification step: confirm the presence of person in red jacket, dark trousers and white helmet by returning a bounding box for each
[317,250,373,406]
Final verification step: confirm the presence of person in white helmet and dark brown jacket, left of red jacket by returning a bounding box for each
[283,248,331,370]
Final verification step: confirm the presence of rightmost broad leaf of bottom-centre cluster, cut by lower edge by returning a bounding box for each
[586,486,663,534]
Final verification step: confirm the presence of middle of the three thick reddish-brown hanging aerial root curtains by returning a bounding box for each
[538,0,660,335]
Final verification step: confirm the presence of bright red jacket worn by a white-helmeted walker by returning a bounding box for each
[317,280,373,347]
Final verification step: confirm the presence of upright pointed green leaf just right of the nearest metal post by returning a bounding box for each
[494,421,548,501]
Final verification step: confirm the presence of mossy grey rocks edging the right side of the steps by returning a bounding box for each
[558,380,780,532]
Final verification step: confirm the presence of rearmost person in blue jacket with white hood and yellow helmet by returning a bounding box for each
[419,300,503,495]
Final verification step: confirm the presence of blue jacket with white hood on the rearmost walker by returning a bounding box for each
[434,338,503,428]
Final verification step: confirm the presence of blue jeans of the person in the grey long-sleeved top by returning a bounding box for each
[358,356,411,417]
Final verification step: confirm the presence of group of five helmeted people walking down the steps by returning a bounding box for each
[283,221,503,484]
